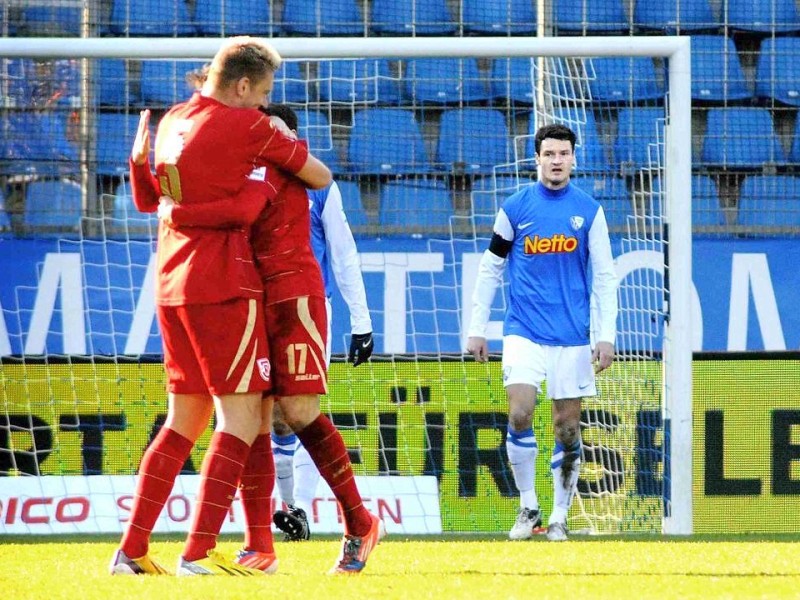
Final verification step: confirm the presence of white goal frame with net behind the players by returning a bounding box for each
[0,37,691,533]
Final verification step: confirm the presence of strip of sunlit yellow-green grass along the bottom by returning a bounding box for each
[0,537,800,600]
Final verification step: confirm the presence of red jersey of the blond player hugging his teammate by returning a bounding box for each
[132,94,308,306]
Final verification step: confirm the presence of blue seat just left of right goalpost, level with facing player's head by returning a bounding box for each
[614,107,664,169]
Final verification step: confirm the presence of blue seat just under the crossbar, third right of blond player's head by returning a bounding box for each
[403,58,489,104]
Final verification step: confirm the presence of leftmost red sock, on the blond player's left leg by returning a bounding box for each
[120,427,194,558]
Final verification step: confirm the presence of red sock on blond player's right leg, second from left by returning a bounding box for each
[183,431,250,561]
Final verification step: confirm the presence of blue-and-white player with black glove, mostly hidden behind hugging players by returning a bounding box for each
[272,171,374,541]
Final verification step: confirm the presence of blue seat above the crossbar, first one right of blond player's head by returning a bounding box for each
[280,0,364,36]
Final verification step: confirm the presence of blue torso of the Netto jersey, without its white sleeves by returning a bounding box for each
[498,183,607,346]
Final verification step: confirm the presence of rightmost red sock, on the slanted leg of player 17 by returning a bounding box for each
[296,415,372,536]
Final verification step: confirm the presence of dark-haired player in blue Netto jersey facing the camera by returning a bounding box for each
[467,125,617,541]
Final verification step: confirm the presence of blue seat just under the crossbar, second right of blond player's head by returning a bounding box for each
[319,59,400,104]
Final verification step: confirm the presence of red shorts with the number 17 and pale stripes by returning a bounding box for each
[264,296,328,396]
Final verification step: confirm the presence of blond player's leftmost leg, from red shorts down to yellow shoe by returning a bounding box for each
[110,306,213,575]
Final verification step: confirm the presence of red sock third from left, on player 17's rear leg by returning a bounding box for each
[239,434,275,553]
